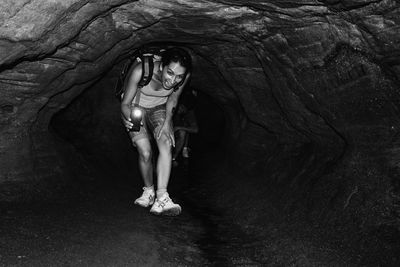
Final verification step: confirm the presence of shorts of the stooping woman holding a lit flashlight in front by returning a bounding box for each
[129,104,166,145]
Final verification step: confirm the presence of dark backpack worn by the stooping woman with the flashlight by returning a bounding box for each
[114,47,165,101]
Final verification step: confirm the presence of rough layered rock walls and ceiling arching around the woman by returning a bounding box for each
[0,0,400,264]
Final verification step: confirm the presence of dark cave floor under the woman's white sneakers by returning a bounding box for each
[0,152,352,266]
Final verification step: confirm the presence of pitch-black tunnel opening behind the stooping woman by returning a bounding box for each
[49,50,227,184]
